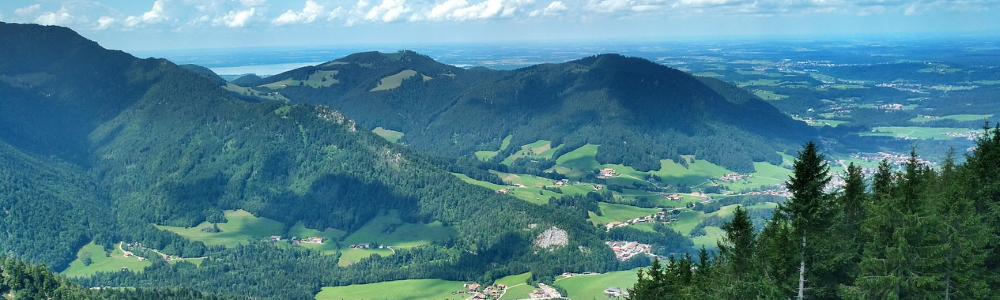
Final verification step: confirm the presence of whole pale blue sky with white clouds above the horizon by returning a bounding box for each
[0,0,1000,51]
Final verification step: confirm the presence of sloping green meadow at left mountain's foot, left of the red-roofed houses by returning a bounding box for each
[156,210,285,247]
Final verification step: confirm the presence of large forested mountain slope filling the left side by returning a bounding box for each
[0,23,622,299]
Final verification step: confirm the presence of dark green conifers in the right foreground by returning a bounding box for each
[630,126,1000,299]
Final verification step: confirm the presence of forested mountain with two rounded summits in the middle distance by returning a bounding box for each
[246,51,812,172]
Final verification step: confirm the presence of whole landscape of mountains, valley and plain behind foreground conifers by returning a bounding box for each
[0,19,1000,299]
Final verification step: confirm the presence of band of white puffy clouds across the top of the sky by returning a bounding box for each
[0,0,1000,30]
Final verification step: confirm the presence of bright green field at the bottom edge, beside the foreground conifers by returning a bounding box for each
[556,269,639,300]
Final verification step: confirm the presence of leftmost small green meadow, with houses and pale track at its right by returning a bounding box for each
[62,242,151,277]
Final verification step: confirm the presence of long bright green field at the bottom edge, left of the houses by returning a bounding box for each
[316,279,466,300]
